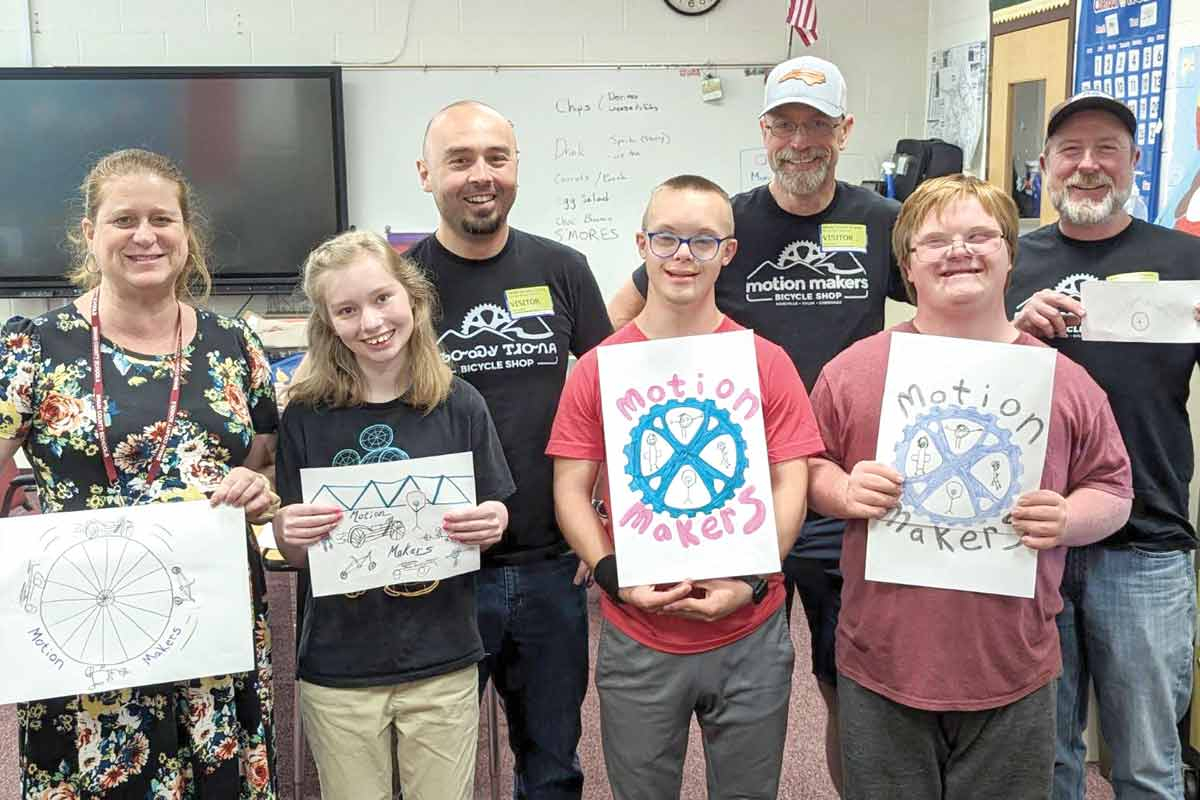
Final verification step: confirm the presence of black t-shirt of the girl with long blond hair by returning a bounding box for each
[275,378,514,687]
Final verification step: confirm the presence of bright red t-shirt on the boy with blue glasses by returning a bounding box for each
[546,317,824,655]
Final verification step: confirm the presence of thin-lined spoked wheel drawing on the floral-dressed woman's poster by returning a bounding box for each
[41,534,177,667]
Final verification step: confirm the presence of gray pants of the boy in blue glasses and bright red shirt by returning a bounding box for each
[596,608,794,800]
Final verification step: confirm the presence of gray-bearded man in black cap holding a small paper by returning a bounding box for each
[1007,91,1200,800]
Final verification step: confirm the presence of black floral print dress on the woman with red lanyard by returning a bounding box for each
[0,305,278,800]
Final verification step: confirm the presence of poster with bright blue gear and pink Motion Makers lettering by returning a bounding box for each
[598,331,779,587]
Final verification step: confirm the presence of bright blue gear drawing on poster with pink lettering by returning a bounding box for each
[624,398,749,517]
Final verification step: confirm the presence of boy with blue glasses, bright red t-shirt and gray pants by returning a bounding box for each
[546,175,823,800]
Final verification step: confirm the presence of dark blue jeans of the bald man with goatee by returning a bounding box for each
[478,554,588,800]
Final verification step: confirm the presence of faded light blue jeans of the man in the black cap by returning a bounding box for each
[1054,545,1196,800]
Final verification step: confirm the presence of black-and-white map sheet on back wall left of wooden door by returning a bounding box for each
[925,41,988,166]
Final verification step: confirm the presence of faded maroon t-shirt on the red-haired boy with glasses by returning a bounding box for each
[812,323,1133,711]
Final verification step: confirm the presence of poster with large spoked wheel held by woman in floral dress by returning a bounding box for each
[0,500,254,703]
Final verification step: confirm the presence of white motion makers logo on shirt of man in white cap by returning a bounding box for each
[746,241,871,306]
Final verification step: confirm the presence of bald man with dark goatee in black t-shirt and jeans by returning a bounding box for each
[417,101,612,800]
